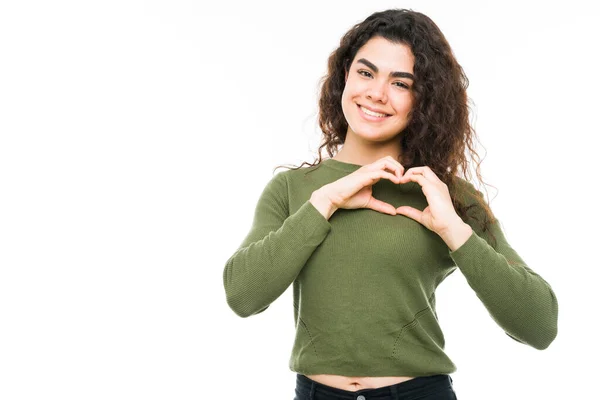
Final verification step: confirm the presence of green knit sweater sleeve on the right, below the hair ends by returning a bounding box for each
[450,183,558,350]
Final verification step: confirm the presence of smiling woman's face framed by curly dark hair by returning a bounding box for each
[342,37,414,142]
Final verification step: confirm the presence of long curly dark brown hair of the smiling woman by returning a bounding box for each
[274,9,497,247]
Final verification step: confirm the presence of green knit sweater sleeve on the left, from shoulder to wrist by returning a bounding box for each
[223,172,331,318]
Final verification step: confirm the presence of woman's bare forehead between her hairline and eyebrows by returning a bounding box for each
[352,37,415,72]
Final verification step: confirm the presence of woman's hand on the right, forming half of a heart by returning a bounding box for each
[396,166,463,236]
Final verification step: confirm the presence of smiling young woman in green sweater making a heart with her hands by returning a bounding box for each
[223,9,558,400]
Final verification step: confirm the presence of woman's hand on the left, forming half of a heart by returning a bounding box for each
[318,156,404,215]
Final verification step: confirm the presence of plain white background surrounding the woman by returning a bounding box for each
[0,0,600,400]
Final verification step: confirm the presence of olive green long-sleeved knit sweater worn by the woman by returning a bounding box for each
[223,159,558,376]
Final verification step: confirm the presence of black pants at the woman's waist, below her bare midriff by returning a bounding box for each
[294,374,457,400]
